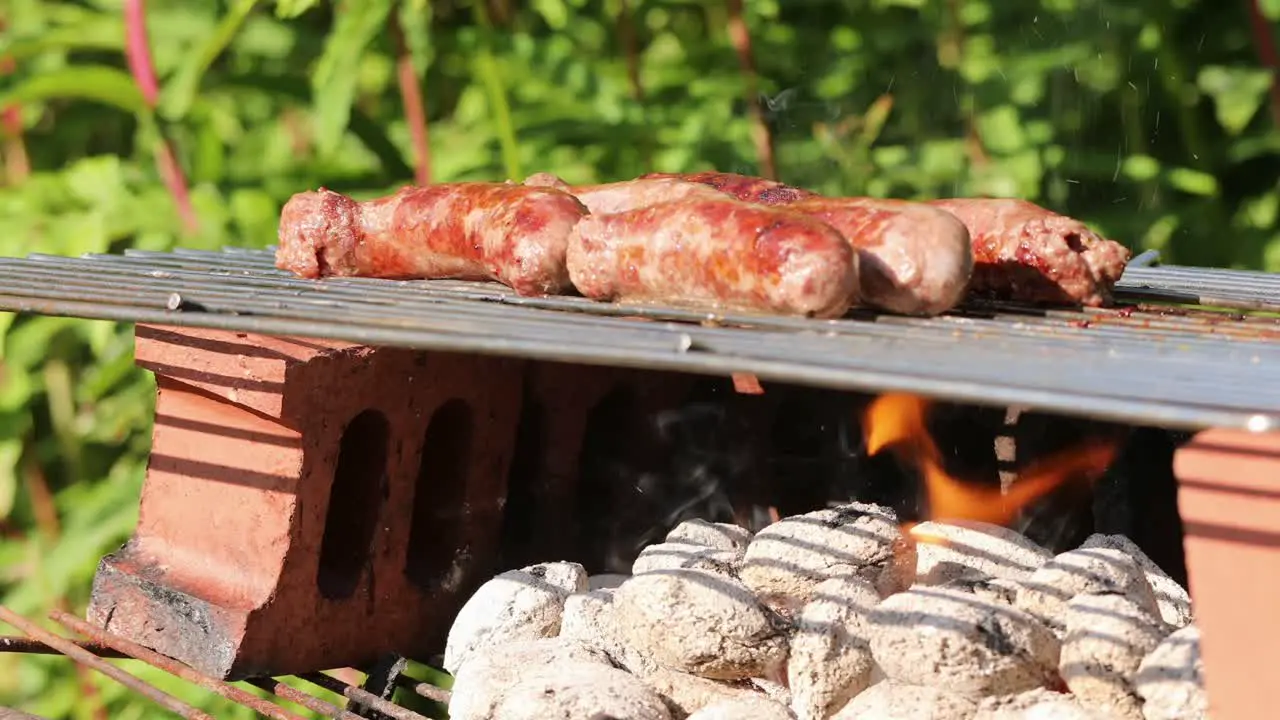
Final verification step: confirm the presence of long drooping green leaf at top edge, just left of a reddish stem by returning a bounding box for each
[311,0,394,155]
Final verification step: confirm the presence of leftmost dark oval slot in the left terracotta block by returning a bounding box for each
[316,410,390,600]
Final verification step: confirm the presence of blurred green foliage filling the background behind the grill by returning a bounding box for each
[0,0,1280,719]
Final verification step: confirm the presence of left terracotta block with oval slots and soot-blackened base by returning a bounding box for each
[88,325,522,679]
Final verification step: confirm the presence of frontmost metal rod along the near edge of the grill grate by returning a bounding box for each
[0,286,1280,430]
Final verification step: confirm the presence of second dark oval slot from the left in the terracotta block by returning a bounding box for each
[404,398,475,592]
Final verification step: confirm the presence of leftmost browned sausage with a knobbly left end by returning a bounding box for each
[275,182,586,295]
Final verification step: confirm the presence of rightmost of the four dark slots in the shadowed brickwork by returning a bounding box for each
[575,386,643,573]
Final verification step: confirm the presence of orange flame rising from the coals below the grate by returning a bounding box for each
[863,395,1117,525]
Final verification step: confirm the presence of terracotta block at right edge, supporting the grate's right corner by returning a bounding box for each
[1174,429,1280,720]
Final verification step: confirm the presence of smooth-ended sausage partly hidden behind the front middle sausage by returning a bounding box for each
[787,197,973,315]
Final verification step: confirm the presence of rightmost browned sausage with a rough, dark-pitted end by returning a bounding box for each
[931,197,1130,306]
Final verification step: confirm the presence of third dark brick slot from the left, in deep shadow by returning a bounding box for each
[502,395,547,566]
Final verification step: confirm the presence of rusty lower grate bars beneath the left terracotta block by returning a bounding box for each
[0,606,451,720]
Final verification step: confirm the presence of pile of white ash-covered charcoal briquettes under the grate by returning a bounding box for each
[445,503,1207,720]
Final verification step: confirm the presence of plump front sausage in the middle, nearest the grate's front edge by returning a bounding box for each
[567,199,858,318]
